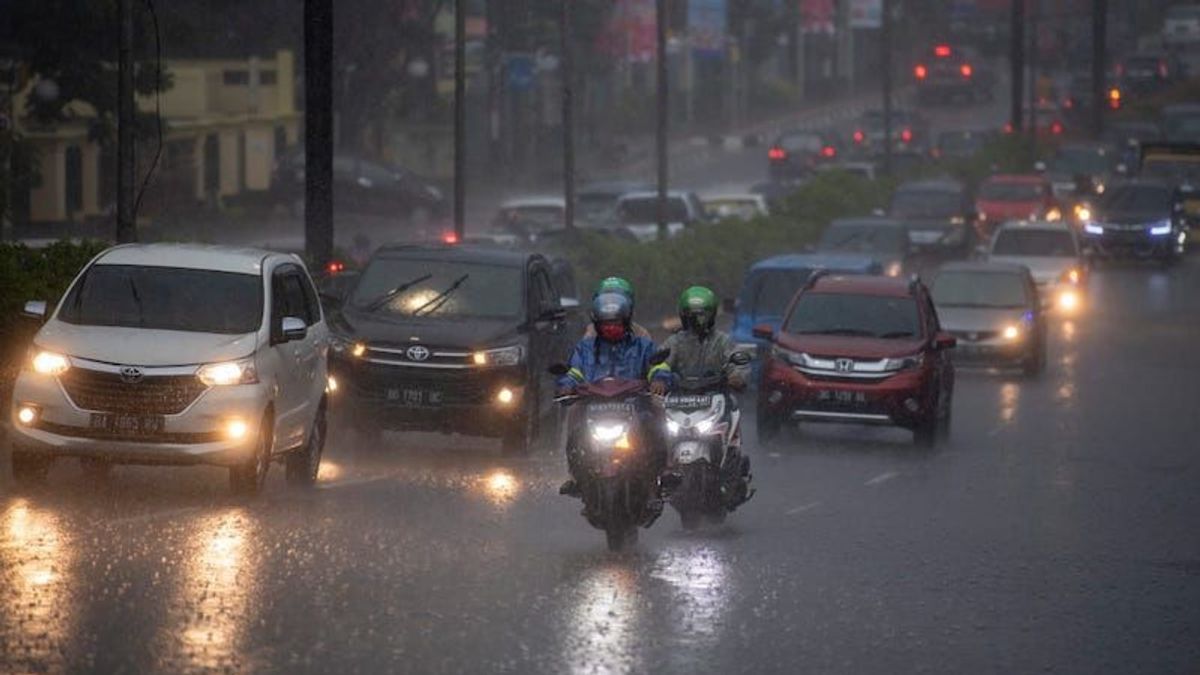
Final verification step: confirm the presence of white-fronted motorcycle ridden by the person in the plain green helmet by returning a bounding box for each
[664,352,754,530]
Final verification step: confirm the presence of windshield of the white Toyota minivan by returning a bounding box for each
[58,264,263,335]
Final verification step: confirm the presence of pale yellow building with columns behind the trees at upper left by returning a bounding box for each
[16,50,300,222]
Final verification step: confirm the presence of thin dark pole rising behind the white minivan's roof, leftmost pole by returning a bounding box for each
[116,0,138,244]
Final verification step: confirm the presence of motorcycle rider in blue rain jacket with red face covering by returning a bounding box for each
[558,291,672,496]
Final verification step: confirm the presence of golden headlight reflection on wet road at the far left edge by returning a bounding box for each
[0,498,76,673]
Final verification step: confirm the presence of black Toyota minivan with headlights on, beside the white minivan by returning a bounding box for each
[330,245,580,453]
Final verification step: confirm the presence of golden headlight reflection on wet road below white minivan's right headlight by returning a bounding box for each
[167,508,259,670]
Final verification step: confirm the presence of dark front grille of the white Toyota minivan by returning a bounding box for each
[59,368,208,414]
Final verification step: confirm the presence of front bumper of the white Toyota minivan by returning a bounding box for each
[10,372,270,466]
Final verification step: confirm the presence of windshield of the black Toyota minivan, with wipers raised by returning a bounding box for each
[350,257,524,318]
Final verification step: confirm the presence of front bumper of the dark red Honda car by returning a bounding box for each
[758,358,934,429]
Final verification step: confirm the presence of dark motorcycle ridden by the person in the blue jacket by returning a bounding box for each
[551,357,666,551]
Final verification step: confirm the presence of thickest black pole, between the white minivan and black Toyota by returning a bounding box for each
[304,0,334,268]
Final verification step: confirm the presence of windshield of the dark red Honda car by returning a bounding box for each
[784,293,920,339]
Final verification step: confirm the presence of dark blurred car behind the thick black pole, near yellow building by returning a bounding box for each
[271,148,449,221]
